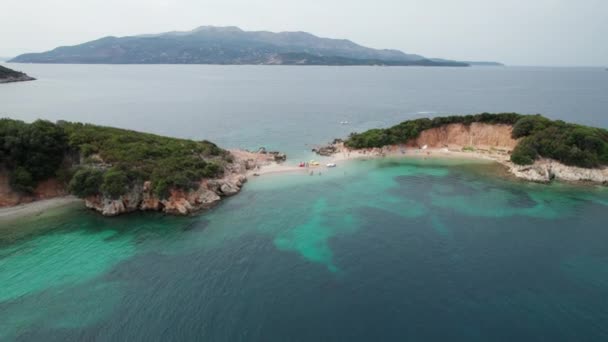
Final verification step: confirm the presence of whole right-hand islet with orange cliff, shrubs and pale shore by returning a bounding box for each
[315,113,608,185]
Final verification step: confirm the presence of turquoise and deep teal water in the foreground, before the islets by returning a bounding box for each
[0,159,608,341]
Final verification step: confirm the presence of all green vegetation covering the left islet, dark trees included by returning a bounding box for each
[0,119,231,198]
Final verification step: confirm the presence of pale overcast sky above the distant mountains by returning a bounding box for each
[0,0,608,66]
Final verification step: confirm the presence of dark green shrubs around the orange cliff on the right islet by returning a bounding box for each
[345,113,608,168]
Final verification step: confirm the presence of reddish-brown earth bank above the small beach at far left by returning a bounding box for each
[0,169,67,208]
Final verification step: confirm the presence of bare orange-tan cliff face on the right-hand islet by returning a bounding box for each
[407,123,517,150]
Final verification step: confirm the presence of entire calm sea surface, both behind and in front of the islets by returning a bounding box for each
[0,64,608,342]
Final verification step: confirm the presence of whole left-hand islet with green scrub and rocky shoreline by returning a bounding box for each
[0,119,286,216]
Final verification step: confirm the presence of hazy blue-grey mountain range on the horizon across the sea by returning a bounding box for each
[10,26,502,66]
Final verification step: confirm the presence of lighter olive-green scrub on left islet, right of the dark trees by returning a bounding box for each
[59,122,229,198]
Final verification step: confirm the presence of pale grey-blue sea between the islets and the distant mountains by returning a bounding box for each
[0,64,608,156]
